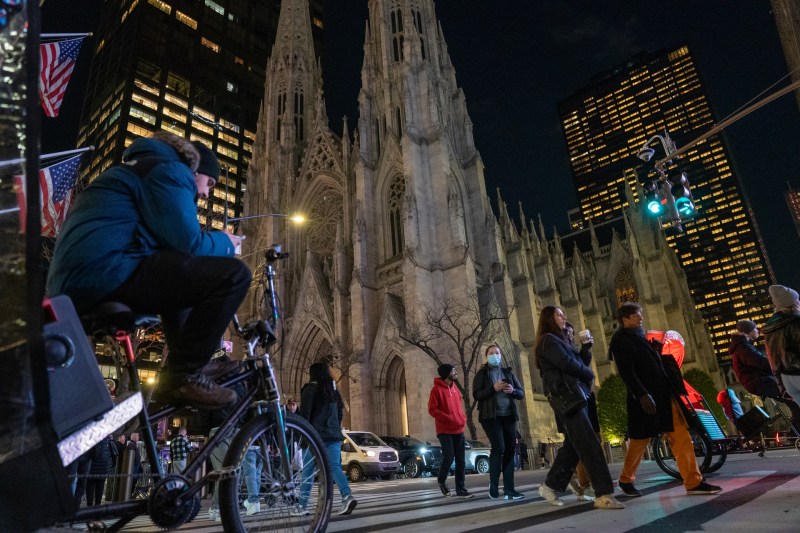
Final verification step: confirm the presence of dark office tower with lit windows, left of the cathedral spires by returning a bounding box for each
[78,0,323,228]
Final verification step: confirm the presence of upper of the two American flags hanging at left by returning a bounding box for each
[39,37,83,117]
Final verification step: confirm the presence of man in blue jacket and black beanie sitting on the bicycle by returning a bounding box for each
[47,132,251,409]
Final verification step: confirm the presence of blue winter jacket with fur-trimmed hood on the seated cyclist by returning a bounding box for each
[47,138,234,311]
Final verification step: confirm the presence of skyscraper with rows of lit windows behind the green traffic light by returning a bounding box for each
[559,45,774,361]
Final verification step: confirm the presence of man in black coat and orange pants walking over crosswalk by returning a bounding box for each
[609,302,722,497]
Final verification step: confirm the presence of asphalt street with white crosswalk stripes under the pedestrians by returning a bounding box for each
[114,463,800,533]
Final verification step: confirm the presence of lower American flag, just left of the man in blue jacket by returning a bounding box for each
[14,154,81,238]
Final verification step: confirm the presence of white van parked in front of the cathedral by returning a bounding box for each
[342,429,400,481]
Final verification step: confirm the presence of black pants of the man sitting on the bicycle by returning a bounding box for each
[105,250,251,376]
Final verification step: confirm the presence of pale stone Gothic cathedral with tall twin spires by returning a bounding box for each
[240,0,718,443]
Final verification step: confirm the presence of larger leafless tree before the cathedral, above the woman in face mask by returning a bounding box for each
[398,294,515,439]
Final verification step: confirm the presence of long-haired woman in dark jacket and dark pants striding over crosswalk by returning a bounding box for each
[534,305,625,509]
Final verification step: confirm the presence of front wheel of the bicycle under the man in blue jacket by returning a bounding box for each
[219,413,333,533]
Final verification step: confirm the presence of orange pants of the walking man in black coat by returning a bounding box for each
[619,398,703,490]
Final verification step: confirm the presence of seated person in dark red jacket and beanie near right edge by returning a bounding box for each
[728,320,800,429]
